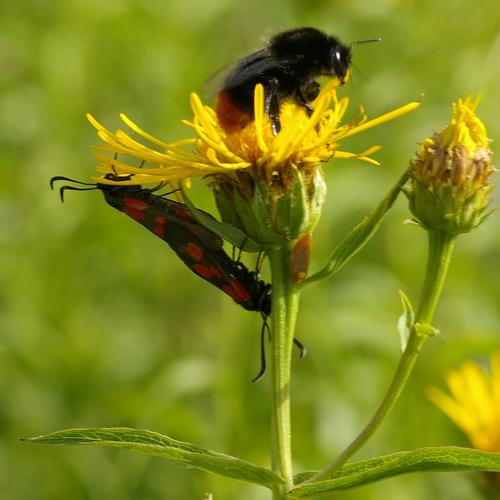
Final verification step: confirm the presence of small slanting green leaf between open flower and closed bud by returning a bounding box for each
[302,170,409,286]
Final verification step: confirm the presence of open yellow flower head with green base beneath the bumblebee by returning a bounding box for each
[89,80,419,245]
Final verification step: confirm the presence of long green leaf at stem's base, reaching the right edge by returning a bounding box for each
[288,446,500,499]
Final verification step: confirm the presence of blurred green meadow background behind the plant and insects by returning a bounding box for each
[0,0,500,500]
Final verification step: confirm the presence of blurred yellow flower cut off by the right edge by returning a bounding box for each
[428,352,500,452]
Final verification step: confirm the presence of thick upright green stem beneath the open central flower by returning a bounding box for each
[267,243,299,500]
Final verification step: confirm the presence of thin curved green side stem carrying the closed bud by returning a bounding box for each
[305,231,455,483]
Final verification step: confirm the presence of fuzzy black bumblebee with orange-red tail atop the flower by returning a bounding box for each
[215,28,378,135]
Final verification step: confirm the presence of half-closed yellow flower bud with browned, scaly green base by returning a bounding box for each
[407,97,495,235]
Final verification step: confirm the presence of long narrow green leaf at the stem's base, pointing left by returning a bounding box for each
[26,427,285,488]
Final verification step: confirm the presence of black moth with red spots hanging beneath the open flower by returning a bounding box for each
[50,174,271,317]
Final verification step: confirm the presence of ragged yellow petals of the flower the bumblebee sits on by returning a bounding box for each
[88,82,420,185]
